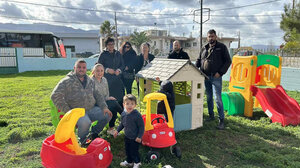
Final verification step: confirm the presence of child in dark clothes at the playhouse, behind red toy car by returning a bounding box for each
[156,77,175,121]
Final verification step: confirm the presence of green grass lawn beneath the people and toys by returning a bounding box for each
[0,71,300,168]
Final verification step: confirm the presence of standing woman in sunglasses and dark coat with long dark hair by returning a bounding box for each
[120,41,137,94]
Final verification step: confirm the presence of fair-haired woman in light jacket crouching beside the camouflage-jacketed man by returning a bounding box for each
[90,63,123,135]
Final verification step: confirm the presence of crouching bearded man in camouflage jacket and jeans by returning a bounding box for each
[51,59,112,146]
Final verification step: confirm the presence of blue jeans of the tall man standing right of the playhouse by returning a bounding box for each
[205,76,224,120]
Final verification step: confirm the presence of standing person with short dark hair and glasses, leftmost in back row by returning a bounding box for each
[98,37,124,107]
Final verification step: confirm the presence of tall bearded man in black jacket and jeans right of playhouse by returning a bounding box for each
[196,29,231,130]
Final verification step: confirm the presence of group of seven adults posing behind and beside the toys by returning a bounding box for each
[51,30,231,144]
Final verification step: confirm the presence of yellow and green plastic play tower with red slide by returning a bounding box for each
[222,55,300,126]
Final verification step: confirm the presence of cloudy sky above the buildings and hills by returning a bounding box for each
[0,0,292,47]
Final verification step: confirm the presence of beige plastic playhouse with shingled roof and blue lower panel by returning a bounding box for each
[136,58,204,131]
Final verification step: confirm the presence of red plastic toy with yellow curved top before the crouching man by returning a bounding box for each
[41,108,113,168]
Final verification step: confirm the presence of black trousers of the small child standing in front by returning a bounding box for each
[125,136,141,163]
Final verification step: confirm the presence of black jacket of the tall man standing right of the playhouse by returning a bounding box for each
[196,41,231,76]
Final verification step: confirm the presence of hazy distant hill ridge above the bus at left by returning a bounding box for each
[0,23,99,34]
